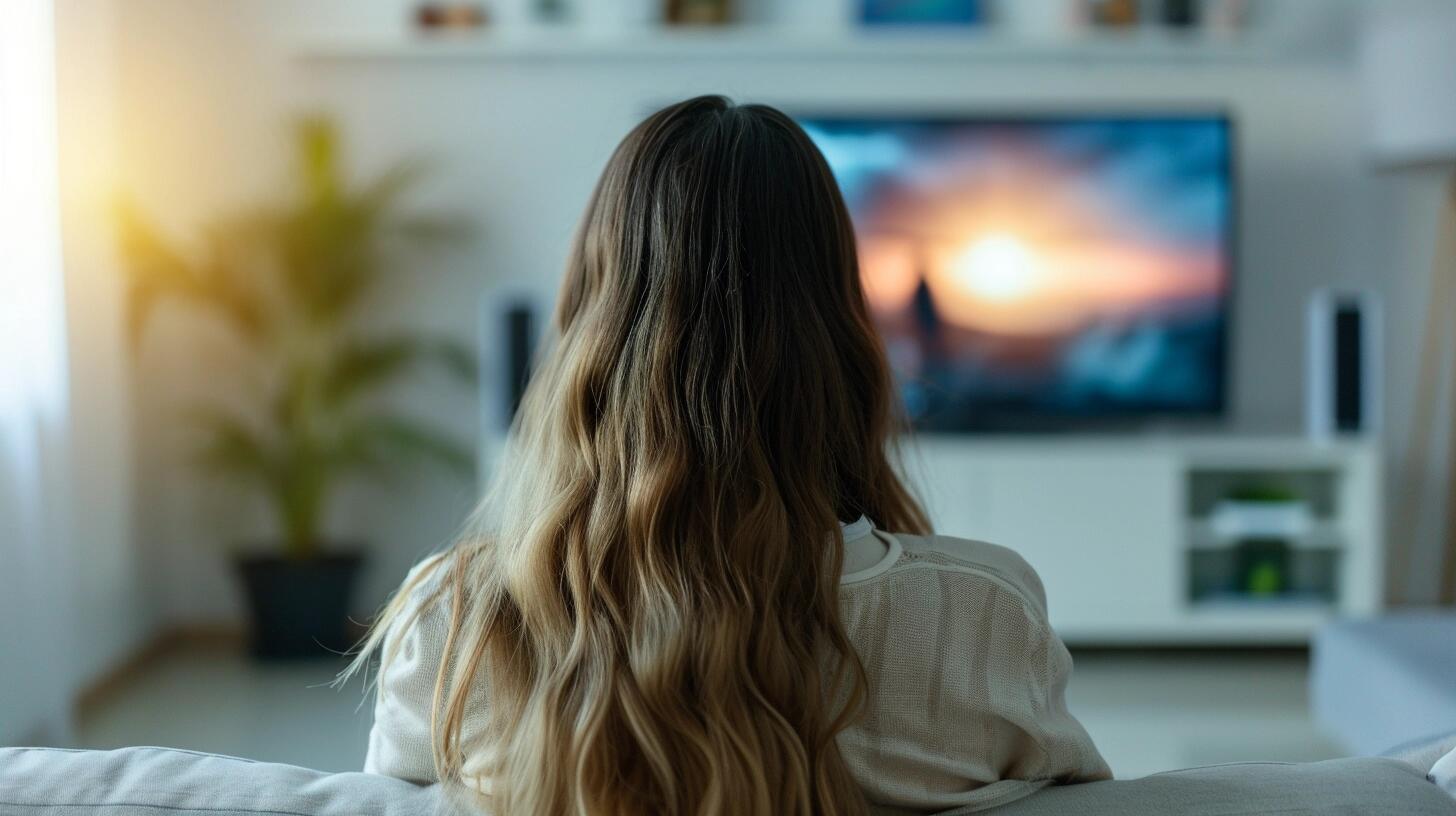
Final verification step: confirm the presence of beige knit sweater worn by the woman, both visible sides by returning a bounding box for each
[364,519,1111,813]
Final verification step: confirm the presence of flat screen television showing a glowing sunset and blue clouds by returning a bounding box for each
[799,114,1235,431]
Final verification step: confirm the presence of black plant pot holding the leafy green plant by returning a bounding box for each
[236,552,364,660]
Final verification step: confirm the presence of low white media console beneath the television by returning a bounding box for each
[904,434,1383,646]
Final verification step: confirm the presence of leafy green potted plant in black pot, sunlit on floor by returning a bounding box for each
[119,118,476,657]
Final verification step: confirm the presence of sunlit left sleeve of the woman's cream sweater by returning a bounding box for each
[364,557,447,784]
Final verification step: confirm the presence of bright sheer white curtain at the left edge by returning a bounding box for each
[0,0,71,745]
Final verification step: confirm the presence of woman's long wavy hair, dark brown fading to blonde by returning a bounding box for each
[347,96,927,815]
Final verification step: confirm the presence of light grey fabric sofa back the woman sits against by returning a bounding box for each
[0,734,1456,816]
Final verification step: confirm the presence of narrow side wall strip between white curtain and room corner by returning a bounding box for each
[55,0,154,702]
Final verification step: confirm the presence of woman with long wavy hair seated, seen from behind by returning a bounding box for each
[355,96,1108,815]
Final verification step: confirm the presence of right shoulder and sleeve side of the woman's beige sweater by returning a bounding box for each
[840,539,1111,813]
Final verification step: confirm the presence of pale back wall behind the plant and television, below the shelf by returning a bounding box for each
[93,0,1456,619]
